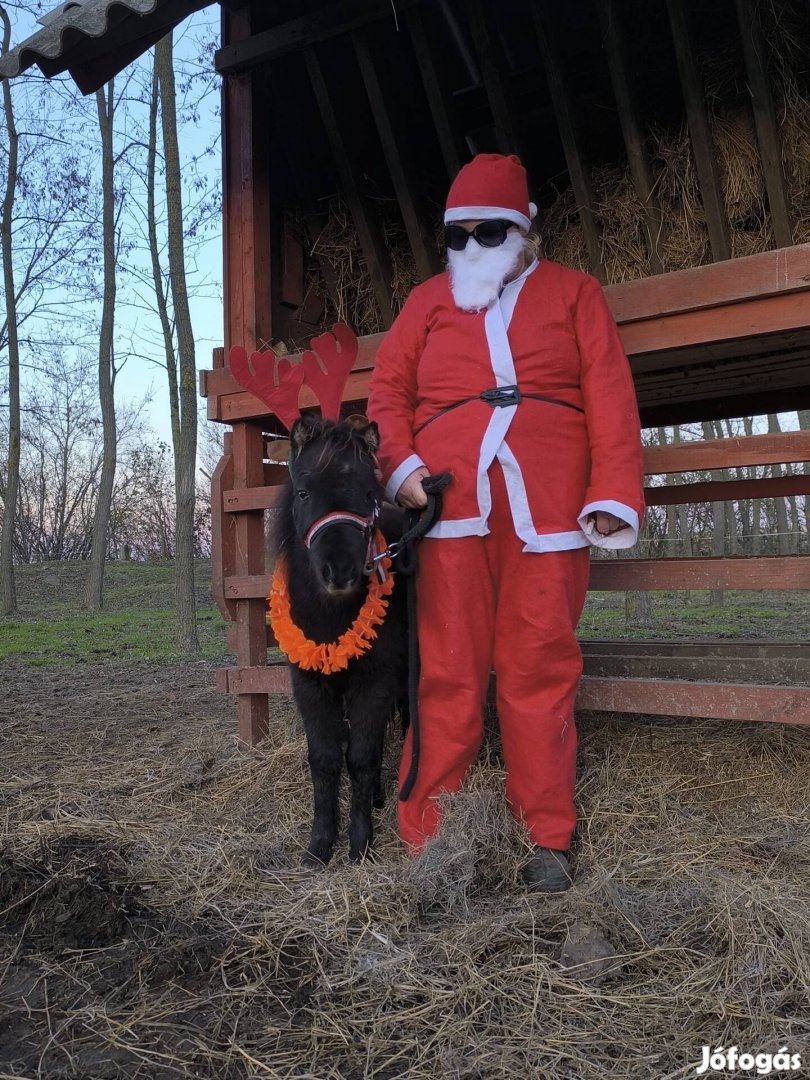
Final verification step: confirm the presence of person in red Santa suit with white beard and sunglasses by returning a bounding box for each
[368,154,644,891]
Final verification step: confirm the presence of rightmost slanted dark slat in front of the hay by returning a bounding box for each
[737,0,793,247]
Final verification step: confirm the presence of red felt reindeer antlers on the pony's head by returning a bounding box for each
[228,323,357,429]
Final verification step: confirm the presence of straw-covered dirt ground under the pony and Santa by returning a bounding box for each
[0,663,810,1080]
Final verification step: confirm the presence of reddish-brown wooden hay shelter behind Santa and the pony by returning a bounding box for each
[3,0,810,743]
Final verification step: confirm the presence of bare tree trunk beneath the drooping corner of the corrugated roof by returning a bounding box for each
[84,80,118,611]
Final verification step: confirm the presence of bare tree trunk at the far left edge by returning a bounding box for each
[0,6,21,615]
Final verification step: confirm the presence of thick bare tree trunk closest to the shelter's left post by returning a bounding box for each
[154,32,200,652]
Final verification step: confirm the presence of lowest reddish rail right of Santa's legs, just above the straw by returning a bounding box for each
[577,676,810,725]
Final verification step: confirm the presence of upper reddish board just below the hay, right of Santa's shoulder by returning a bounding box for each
[605,244,810,325]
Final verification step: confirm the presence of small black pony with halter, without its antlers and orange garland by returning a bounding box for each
[274,418,407,866]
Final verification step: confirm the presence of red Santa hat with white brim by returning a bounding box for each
[444,153,537,229]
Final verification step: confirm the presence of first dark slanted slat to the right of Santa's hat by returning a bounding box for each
[531,0,607,284]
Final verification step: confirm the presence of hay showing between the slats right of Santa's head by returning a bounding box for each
[540,0,810,284]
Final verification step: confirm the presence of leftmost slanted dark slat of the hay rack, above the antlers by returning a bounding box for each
[303,49,394,326]
